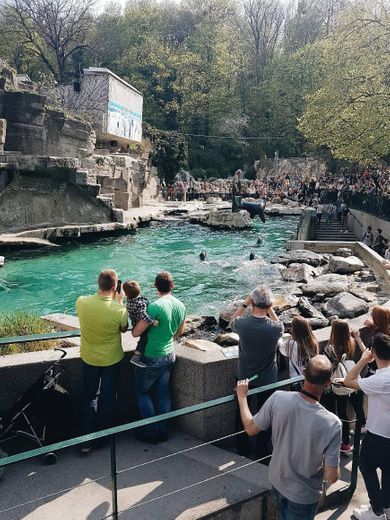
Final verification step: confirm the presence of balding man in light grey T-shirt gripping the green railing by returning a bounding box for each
[237,356,341,520]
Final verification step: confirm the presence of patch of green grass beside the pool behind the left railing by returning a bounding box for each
[0,312,60,356]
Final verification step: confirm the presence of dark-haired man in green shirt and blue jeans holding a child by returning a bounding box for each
[132,271,186,443]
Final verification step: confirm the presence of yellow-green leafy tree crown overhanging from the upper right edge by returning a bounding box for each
[299,3,390,164]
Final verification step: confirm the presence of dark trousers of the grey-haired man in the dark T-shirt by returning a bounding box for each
[236,391,273,459]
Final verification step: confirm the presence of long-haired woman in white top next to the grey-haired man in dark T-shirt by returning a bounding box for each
[279,316,318,377]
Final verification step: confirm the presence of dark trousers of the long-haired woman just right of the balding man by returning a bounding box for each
[321,392,366,444]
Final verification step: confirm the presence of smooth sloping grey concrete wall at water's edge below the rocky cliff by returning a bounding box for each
[0,174,112,232]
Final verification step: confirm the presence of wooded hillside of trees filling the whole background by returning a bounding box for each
[0,0,390,173]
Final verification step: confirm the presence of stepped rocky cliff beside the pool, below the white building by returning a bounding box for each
[0,64,159,233]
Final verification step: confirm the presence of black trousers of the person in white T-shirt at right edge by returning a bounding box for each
[359,432,390,515]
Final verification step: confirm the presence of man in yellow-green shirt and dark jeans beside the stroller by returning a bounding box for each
[76,269,128,453]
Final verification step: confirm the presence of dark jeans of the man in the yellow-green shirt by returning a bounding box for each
[82,361,121,434]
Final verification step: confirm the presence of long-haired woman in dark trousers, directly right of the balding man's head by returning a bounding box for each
[324,320,365,453]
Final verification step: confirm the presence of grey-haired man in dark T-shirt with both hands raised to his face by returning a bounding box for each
[230,286,284,458]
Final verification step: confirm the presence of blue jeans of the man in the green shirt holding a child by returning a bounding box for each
[135,352,175,436]
